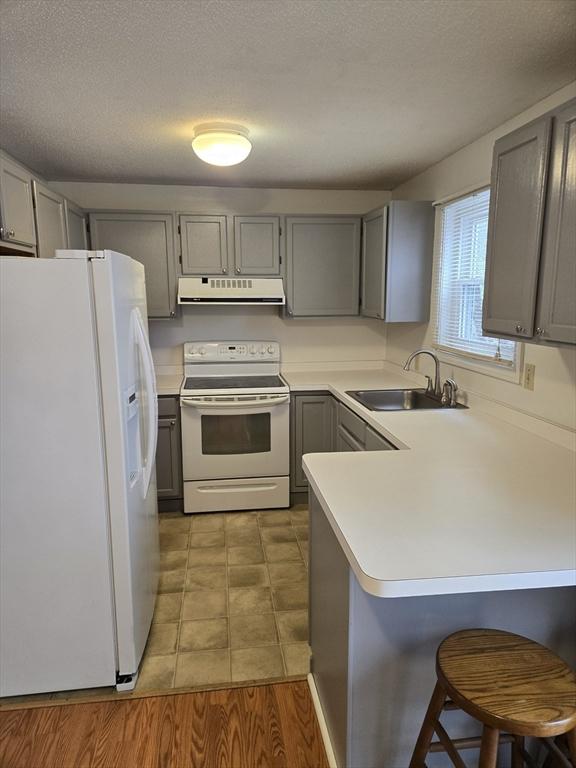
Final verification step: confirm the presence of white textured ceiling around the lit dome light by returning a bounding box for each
[0,0,576,189]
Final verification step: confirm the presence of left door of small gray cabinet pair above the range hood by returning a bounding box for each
[180,216,228,275]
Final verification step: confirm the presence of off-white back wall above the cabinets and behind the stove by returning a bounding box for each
[51,182,390,366]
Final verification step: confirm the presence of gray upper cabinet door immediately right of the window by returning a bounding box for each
[482,117,552,338]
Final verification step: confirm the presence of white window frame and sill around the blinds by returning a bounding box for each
[430,184,524,384]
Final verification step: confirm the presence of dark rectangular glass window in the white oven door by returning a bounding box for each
[202,413,270,456]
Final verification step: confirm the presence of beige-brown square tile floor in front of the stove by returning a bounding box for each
[136,506,310,691]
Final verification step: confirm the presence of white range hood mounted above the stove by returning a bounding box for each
[178,277,286,306]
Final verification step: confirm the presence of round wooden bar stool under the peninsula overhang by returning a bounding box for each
[410,629,576,768]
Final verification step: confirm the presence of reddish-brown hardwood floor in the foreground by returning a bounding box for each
[0,681,328,768]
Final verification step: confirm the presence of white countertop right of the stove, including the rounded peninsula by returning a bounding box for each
[284,371,576,597]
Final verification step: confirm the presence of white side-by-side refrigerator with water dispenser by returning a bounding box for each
[0,251,159,696]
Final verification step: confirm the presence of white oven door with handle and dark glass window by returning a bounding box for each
[180,394,290,481]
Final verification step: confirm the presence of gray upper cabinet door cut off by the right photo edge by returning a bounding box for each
[537,100,576,344]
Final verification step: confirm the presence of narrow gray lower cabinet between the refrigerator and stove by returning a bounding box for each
[156,396,184,506]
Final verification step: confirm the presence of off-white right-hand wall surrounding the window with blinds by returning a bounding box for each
[386,82,576,429]
